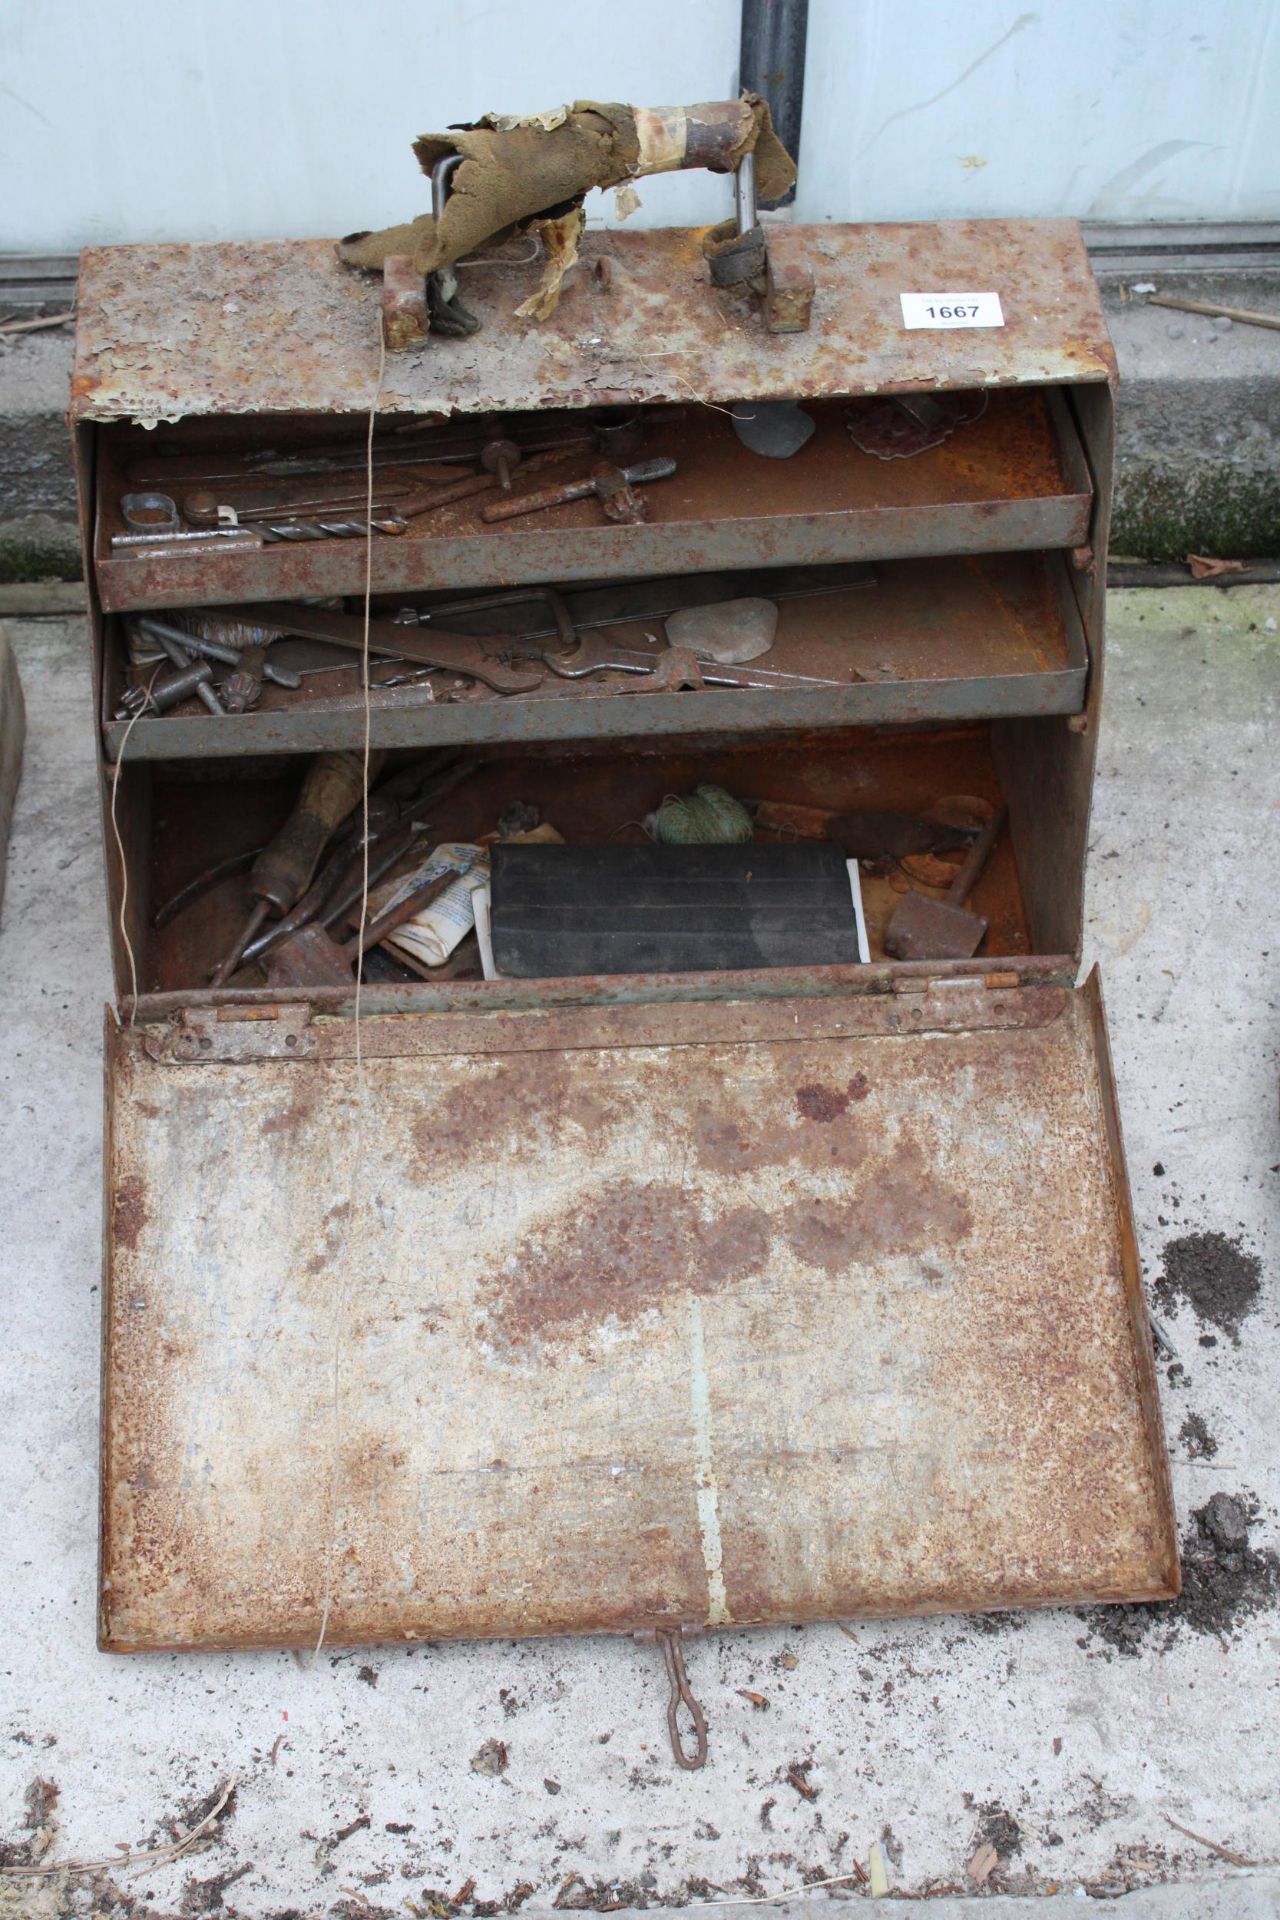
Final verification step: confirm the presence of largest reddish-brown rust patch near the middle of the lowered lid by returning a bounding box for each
[482,1181,770,1346]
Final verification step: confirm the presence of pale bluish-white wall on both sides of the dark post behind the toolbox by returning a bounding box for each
[0,0,1280,252]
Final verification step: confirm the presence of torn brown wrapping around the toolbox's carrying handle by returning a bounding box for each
[338,94,796,275]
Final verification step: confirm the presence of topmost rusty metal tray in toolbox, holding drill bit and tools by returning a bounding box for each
[96,390,1092,609]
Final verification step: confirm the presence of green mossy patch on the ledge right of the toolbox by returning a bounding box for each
[1111,459,1280,561]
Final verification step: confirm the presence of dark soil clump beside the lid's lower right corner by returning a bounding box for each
[1080,1494,1280,1655]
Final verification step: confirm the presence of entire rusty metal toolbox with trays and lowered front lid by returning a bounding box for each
[71,206,1178,1649]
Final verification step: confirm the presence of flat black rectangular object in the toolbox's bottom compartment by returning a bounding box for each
[491,841,858,979]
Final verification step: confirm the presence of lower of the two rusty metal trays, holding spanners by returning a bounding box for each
[102,553,1088,760]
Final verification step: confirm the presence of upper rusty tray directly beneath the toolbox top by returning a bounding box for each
[94,388,1092,612]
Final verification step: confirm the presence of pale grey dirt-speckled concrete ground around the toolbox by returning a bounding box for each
[0,589,1280,1920]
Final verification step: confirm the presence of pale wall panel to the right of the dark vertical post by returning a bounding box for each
[796,0,1280,221]
